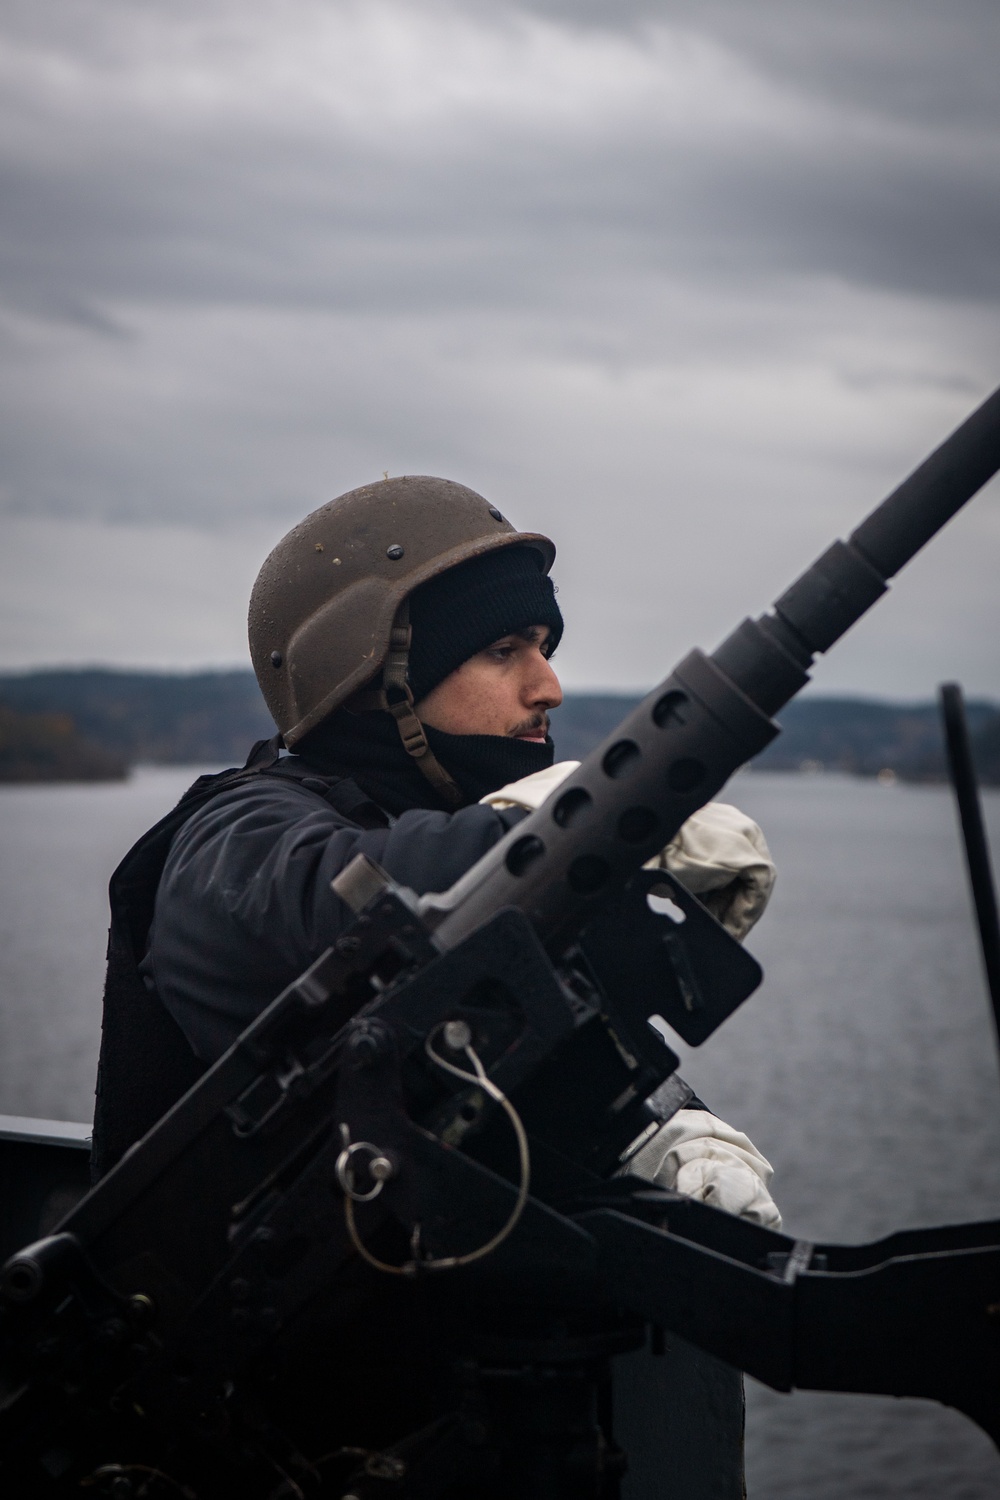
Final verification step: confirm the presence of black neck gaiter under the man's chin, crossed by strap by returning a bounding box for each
[297,708,553,818]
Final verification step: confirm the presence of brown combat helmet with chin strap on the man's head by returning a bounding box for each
[249,474,555,795]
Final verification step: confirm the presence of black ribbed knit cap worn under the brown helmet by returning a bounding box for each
[409,546,562,702]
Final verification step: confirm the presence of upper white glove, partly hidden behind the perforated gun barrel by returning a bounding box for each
[481,761,775,941]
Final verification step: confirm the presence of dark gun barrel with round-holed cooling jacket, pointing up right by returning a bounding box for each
[424,389,1000,953]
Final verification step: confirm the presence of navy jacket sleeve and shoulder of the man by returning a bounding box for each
[141,774,523,1062]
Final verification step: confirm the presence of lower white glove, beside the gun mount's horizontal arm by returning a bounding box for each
[625,1110,781,1230]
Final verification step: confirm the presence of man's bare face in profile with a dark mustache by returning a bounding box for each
[417,626,562,741]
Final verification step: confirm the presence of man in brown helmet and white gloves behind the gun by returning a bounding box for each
[94,477,780,1488]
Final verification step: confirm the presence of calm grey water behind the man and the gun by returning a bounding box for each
[0,770,1000,1500]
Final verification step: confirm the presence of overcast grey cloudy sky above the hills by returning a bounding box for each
[0,0,1000,698]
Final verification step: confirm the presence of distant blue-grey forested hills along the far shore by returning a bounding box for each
[0,668,1000,786]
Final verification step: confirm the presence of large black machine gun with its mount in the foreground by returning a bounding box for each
[0,392,1000,1500]
